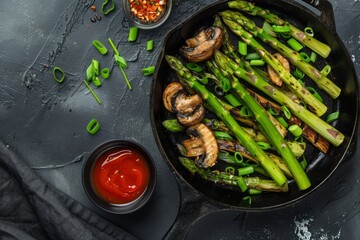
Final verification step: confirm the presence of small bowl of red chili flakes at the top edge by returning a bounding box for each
[123,0,172,29]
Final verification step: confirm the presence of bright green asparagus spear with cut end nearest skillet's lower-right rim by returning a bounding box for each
[207,61,311,190]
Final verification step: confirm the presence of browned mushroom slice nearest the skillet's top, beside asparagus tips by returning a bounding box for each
[180,27,224,62]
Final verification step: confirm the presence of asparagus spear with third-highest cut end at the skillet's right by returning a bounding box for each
[220,13,327,116]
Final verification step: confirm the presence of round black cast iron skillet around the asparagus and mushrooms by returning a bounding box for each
[150,0,359,210]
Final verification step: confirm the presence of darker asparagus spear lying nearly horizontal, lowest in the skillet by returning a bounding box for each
[179,157,288,192]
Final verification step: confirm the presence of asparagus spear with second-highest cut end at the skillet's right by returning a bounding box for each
[222,11,341,99]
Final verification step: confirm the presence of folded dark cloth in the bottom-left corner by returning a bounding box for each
[0,143,136,240]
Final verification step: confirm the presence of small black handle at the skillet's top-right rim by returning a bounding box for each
[302,0,336,33]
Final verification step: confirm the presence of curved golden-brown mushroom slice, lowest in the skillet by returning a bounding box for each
[188,123,219,168]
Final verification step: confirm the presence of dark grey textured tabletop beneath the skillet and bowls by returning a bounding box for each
[0,0,360,240]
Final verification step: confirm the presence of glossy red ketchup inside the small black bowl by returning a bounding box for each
[93,147,150,204]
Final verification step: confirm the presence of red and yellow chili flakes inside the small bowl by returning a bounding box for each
[128,0,166,22]
